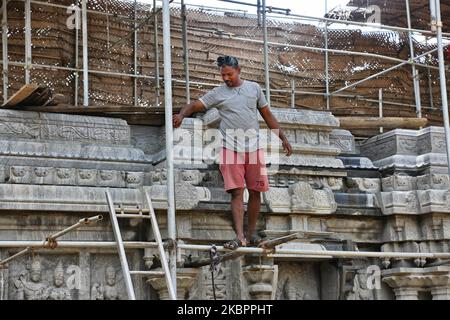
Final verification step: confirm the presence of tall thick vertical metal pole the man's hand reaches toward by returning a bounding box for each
[163,0,177,292]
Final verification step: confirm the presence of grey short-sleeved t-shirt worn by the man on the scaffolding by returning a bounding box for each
[199,80,268,152]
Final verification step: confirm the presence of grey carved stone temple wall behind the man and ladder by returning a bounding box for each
[0,109,450,300]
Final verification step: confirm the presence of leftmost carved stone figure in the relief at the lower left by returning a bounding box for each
[14,259,48,300]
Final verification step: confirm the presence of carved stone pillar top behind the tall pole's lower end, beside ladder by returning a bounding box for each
[146,268,198,300]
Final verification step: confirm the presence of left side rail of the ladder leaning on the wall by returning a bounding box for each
[106,189,136,300]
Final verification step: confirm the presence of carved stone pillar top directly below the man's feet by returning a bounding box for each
[243,265,278,300]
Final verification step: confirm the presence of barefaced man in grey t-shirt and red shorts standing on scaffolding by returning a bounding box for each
[173,56,292,249]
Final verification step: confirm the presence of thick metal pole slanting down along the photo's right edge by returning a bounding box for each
[435,0,450,175]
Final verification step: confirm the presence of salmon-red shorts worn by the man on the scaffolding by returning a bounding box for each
[220,148,269,192]
